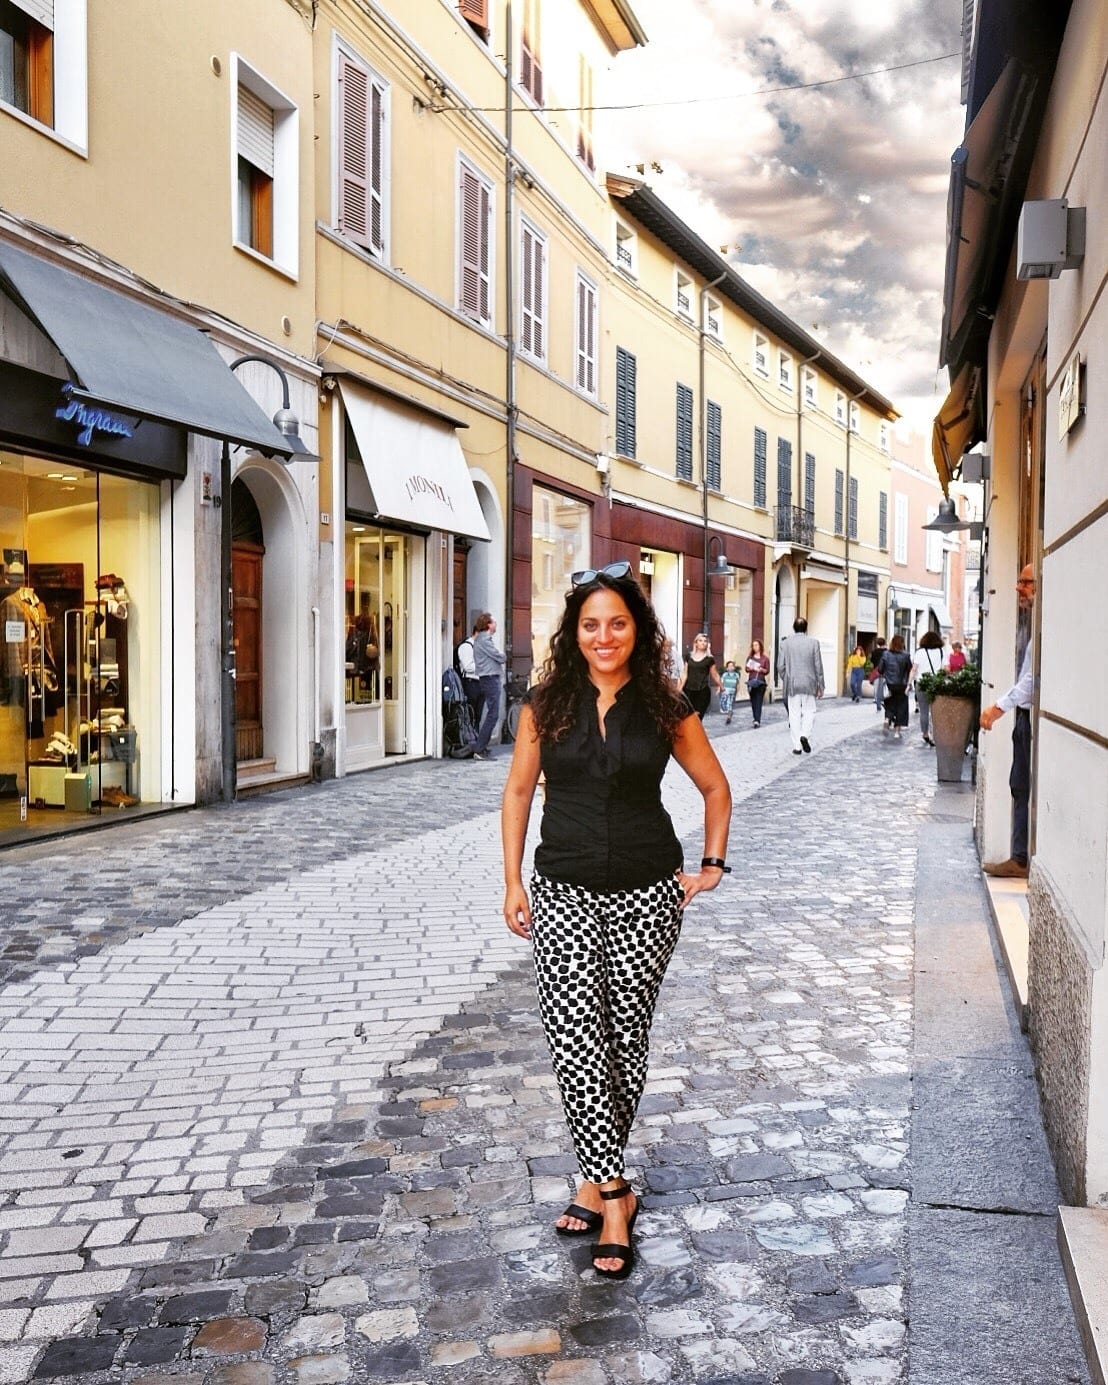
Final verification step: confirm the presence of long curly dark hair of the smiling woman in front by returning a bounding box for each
[530,572,688,744]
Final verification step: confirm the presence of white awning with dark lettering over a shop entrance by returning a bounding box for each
[339,381,492,540]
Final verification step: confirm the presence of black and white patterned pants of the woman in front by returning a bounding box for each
[530,874,683,1183]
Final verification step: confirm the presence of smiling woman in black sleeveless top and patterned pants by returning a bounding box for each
[501,562,731,1278]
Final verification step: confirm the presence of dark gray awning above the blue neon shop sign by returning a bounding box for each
[0,244,291,457]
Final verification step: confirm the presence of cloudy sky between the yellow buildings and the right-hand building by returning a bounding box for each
[604,0,965,432]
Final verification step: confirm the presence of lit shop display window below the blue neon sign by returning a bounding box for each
[0,450,162,839]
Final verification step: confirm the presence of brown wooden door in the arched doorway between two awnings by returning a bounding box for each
[231,479,266,765]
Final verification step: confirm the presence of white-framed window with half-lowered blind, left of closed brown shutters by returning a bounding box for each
[233,54,301,276]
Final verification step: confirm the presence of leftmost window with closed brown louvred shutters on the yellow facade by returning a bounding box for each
[335,46,388,258]
